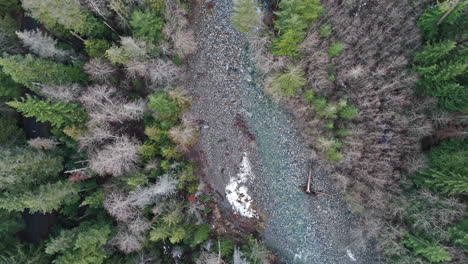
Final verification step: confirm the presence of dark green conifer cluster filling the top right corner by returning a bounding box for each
[413,1,468,111]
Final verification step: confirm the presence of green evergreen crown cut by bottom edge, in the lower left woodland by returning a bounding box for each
[45,222,112,264]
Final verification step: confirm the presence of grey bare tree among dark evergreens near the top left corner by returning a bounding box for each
[16,29,70,61]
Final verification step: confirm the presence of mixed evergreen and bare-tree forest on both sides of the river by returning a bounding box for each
[0,0,468,264]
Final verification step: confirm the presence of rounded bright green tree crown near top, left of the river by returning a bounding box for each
[130,9,164,45]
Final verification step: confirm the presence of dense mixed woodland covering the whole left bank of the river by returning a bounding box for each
[0,0,268,264]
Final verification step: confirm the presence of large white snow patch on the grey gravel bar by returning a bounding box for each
[226,152,258,218]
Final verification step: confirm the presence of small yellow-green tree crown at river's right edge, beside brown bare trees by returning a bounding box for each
[271,65,307,97]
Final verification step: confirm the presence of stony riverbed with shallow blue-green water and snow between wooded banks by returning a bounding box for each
[184,0,379,264]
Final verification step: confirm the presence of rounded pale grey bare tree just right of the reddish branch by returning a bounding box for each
[89,136,140,176]
